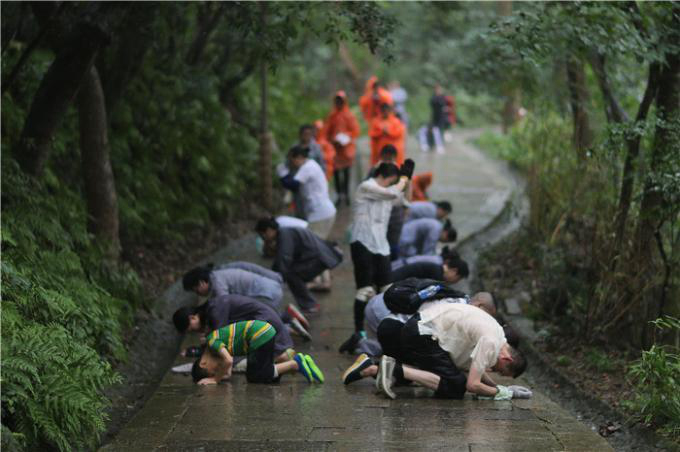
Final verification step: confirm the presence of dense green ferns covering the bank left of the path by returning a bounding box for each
[1,159,140,450]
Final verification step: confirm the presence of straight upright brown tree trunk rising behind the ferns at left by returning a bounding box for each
[78,66,120,261]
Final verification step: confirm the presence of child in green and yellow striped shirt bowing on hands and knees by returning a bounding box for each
[191,320,324,385]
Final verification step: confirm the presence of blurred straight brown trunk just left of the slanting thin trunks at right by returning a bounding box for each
[566,56,593,161]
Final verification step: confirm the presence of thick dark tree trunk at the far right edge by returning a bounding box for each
[635,25,680,345]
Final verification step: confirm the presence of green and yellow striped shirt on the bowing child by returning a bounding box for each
[206,320,276,356]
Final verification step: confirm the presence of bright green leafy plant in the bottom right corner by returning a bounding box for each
[626,316,680,441]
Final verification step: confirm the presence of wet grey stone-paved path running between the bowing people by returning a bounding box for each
[103,129,611,452]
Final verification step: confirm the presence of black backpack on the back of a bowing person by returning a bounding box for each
[384,278,466,314]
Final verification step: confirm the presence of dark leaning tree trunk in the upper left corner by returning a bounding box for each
[15,24,108,176]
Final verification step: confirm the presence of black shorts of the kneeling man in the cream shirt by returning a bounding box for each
[401,314,467,399]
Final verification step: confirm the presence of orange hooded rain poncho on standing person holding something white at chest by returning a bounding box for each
[322,91,361,170]
